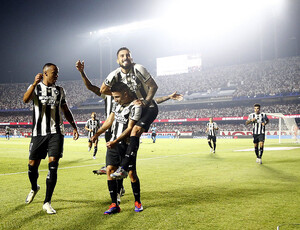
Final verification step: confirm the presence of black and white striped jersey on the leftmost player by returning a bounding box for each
[32,82,66,136]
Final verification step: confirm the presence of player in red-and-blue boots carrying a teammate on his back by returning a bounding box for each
[91,82,143,215]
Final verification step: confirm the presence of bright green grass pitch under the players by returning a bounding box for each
[0,138,300,230]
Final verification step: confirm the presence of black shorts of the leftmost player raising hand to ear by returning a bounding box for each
[29,134,64,160]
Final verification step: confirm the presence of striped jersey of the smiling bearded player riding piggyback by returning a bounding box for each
[104,64,156,106]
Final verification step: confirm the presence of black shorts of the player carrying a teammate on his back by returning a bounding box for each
[106,144,136,171]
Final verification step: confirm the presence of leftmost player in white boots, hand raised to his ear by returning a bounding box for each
[23,63,79,214]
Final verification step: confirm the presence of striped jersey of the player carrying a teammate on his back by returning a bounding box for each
[110,102,142,144]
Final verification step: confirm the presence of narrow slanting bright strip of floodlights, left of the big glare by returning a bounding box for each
[90,20,158,36]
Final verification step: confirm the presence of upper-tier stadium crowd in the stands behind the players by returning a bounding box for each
[0,57,300,110]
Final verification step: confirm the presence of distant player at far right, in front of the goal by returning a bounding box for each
[246,104,269,164]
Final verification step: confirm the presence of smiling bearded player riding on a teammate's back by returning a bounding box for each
[100,47,158,178]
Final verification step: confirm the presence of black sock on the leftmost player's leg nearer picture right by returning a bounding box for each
[44,161,58,203]
